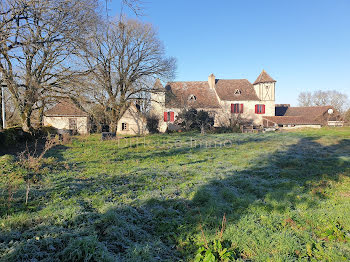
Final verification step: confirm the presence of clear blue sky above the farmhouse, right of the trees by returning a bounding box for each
[109,0,350,105]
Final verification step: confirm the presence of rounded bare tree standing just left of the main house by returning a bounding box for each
[82,19,176,132]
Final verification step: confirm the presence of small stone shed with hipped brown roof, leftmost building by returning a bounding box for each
[44,99,89,134]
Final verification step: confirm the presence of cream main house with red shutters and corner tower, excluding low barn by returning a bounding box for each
[151,70,276,132]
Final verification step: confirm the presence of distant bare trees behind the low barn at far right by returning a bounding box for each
[298,90,349,113]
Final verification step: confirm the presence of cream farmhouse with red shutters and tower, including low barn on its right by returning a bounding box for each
[151,70,343,132]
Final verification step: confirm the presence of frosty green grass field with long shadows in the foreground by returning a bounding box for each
[0,128,350,261]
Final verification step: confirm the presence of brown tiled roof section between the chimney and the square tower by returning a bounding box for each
[215,79,259,101]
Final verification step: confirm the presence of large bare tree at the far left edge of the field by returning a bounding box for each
[0,0,96,131]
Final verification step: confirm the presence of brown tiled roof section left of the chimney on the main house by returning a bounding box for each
[165,81,220,108]
